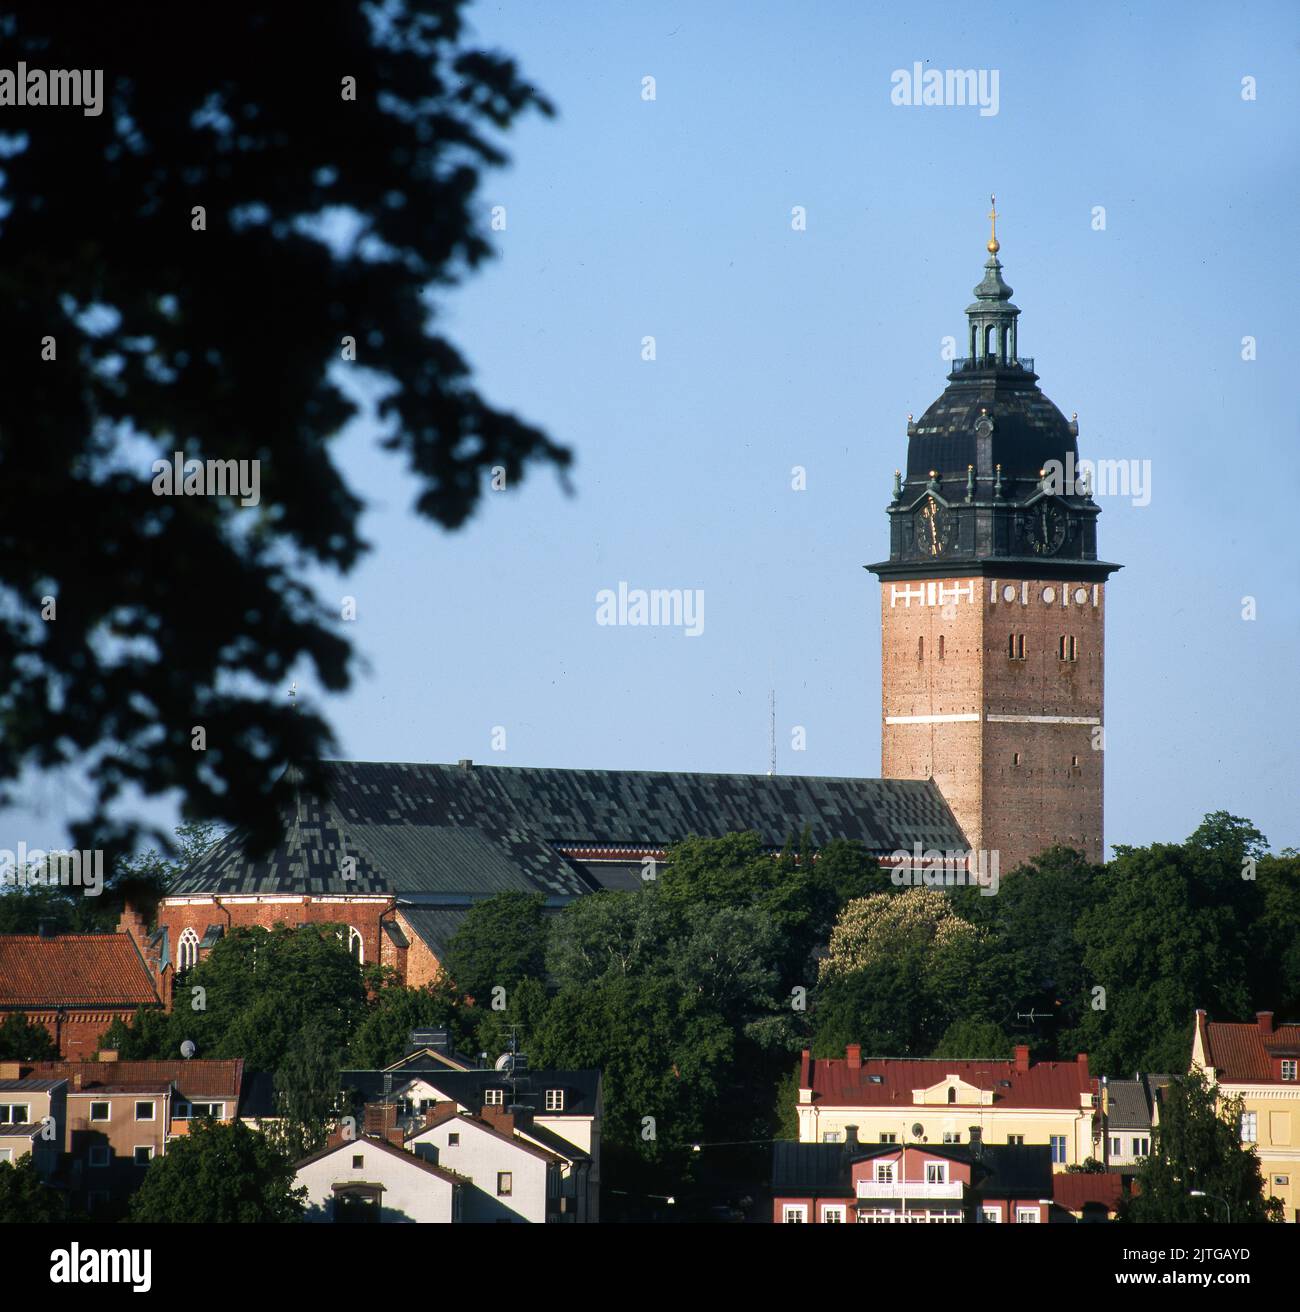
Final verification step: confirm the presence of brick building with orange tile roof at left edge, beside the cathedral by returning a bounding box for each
[0,912,164,1061]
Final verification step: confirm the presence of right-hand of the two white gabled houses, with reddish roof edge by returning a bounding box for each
[405,1102,569,1223]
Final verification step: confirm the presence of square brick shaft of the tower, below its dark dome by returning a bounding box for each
[880,577,1105,874]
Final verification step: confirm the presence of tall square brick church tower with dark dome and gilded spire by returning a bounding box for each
[867,204,1120,874]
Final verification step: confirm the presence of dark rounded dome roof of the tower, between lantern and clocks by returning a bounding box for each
[908,366,1078,480]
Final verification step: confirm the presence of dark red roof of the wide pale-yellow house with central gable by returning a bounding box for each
[800,1057,1098,1110]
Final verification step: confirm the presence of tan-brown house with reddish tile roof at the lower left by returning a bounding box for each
[17,1052,244,1212]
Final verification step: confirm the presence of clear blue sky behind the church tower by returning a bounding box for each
[5,0,1300,849]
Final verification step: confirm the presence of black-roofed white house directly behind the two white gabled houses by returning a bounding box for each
[340,1052,603,1223]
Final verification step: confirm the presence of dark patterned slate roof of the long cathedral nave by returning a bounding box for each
[169,761,967,897]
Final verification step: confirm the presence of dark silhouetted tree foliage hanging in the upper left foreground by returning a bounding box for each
[0,0,568,846]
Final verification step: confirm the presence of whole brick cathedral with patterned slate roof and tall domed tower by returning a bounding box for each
[144,213,1119,996]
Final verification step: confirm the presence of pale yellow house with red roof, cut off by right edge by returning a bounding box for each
[1191,1010,1300,1221]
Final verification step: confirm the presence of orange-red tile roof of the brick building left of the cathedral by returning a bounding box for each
[0,934,159,1010]
